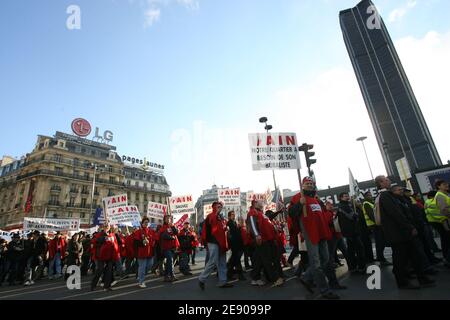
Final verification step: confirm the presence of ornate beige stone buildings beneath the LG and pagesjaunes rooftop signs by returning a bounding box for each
[0,132,171,230]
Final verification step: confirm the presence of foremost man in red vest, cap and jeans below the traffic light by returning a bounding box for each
[289,177,340,300]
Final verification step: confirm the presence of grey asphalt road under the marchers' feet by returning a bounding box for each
[0,252,450,301]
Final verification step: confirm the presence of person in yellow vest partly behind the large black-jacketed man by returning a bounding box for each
[363,191,392,265]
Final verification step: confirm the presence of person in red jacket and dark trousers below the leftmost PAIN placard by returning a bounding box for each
[91,225,120,291]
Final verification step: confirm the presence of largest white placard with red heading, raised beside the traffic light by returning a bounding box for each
[248,133,300,171]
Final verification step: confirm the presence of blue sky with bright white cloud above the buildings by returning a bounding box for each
[0,0,450,200]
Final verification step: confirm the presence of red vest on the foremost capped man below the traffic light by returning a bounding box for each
[291,193,332,244]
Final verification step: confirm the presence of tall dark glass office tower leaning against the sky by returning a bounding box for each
[339,0,442,176]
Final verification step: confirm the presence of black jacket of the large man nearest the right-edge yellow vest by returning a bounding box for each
[378,191,415,245]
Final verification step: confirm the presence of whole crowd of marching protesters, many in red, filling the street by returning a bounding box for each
[0,176,450,299]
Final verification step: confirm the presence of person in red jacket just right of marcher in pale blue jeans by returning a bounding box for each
[159,215,178,282]
